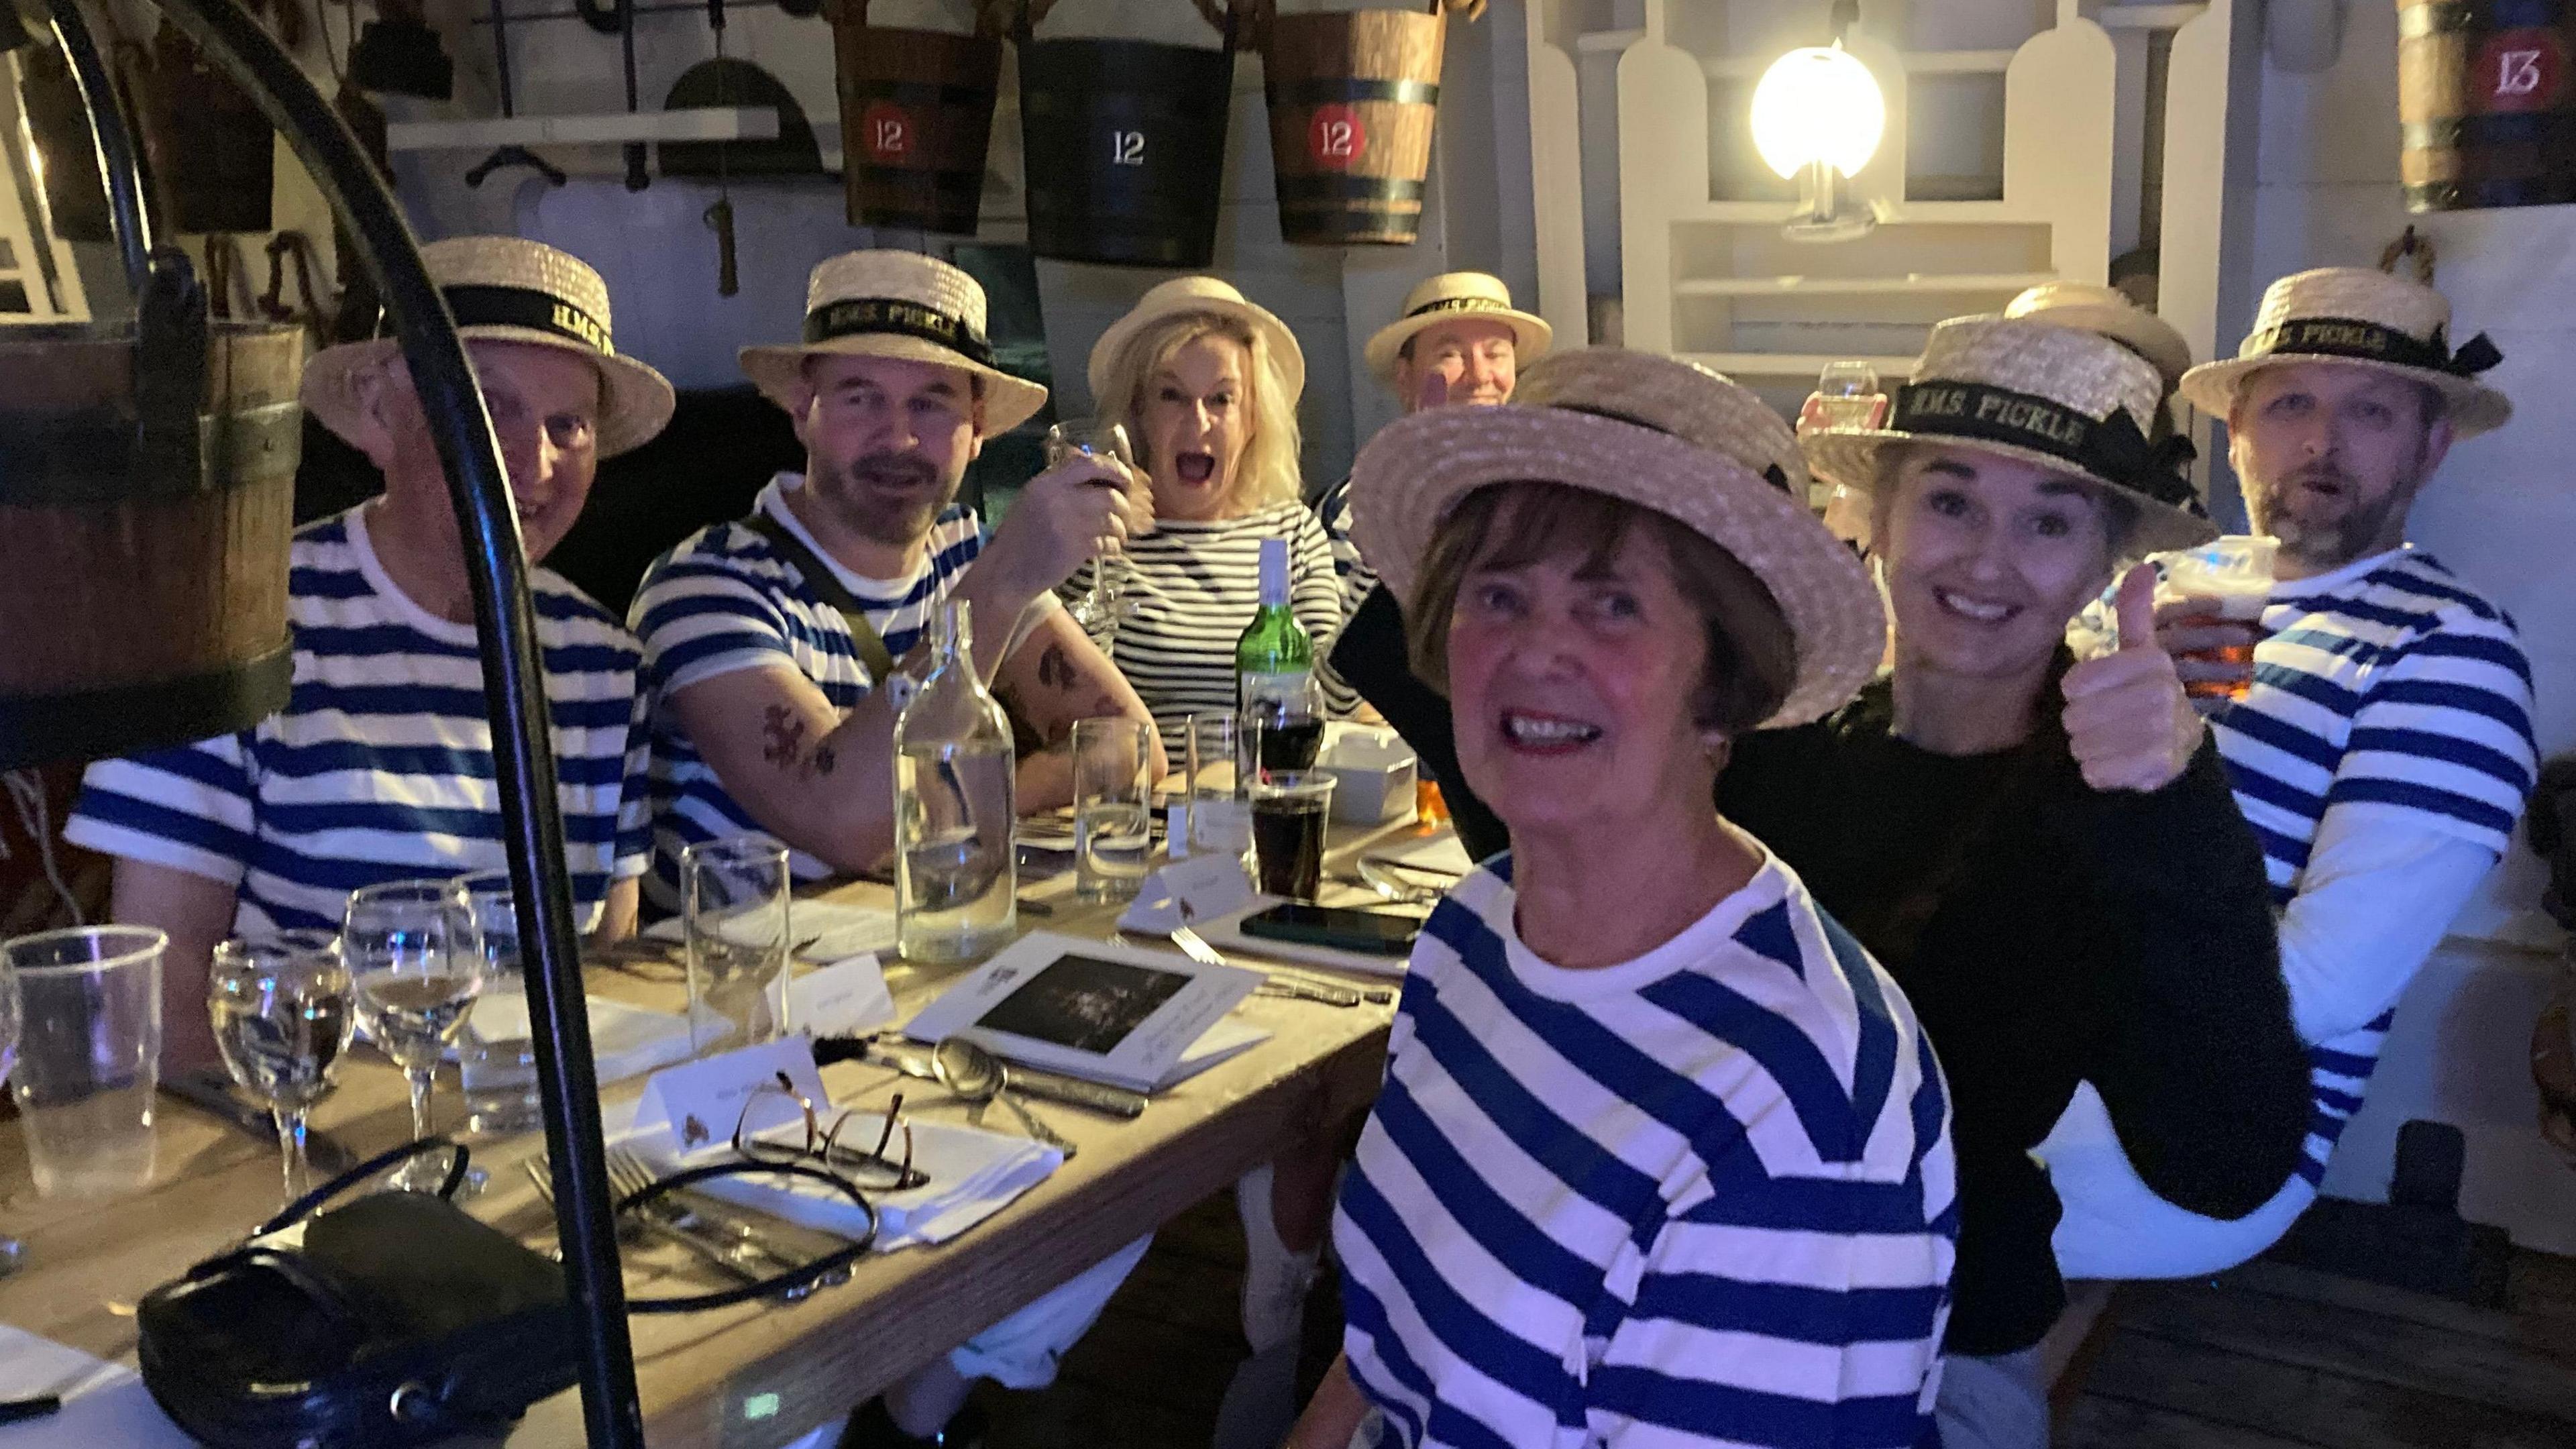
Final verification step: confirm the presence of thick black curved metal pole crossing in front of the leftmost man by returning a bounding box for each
[105,0,644,1449]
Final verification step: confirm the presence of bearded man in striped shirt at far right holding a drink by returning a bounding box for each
[2040,268,2537,1279]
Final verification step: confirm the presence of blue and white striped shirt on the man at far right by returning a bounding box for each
[2210,547,2540,1183]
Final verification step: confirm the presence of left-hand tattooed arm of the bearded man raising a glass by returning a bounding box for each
[665,665,894,874]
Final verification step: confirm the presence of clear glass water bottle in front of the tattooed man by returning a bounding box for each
[894,601,1020,962]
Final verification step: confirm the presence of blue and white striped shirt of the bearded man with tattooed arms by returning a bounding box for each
[626,472,989,910]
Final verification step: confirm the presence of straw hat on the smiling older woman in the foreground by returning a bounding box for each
[1350,348,1888,727]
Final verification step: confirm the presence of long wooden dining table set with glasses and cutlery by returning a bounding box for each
[0,822,1435,1449]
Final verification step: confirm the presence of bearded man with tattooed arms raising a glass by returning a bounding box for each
[629,250,1162,913]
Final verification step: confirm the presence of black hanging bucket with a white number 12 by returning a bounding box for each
[1020,39,1234,271]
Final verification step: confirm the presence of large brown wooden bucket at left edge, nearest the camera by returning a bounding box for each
[0,322,304,768]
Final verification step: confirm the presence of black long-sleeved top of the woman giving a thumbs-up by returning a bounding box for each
[1332,588,2308,1354]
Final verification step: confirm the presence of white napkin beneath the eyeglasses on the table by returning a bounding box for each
[621,1119,1064,1253]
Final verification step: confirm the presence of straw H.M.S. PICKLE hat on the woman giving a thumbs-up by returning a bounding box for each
[1798,317,2218,551]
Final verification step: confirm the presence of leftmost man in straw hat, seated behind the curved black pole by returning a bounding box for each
[64,237,672,1065]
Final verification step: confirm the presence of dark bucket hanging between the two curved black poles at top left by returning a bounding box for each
[131,21,278,235]
